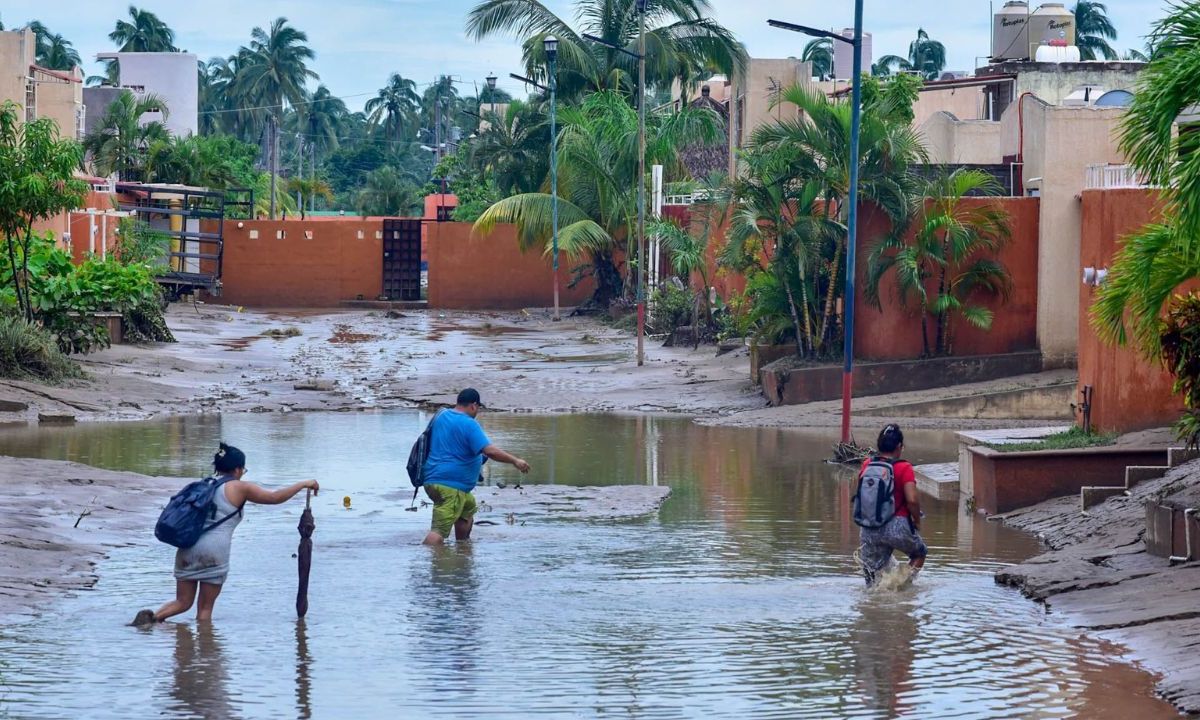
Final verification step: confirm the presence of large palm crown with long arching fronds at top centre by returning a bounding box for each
[467,0,748,100]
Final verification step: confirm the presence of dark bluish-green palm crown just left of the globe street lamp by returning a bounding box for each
[470,101,550,196]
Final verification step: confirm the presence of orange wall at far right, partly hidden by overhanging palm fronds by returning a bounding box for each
[1079,190,1183,431]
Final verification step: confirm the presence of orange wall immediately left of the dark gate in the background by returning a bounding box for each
[221,217,383,307]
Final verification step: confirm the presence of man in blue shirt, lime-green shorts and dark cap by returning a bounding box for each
[424,388,529,545]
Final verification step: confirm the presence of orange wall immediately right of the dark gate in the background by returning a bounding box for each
[427,222,595,310]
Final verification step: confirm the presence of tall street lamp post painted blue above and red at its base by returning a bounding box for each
[768,0,863,443]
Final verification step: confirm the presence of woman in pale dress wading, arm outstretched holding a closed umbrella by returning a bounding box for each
[132,443,320,625]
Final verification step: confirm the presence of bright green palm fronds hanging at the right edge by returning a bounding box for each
[1091,2,1200,359]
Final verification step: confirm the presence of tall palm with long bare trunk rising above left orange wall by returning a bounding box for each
[238,18,319,220]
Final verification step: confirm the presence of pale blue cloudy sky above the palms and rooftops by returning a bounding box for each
[0,0,1168,109]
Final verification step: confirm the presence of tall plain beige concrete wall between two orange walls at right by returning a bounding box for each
[1021,98,1124,366]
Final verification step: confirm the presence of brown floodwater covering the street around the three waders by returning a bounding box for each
[0,412,1174,720]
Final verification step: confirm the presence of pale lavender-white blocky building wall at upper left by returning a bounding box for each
[100,53,199,137]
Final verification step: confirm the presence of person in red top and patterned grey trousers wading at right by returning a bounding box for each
[858,424,929,586]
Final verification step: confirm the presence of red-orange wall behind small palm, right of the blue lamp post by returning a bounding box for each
[854,198,1039,360]
